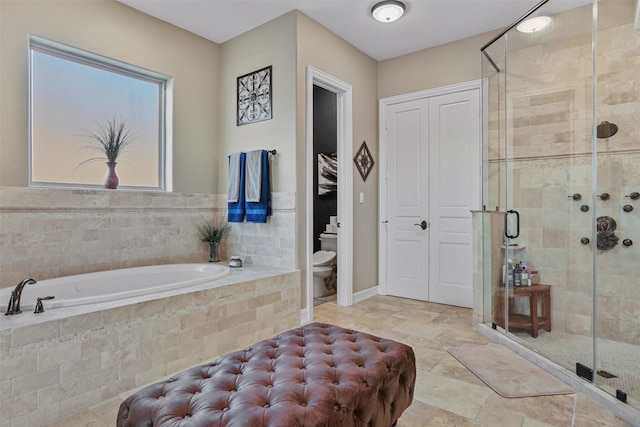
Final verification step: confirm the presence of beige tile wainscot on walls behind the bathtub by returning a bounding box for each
[0,187,295,287]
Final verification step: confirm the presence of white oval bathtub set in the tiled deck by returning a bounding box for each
[0,263,230,312]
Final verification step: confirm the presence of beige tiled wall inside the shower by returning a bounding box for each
[487,20,640,344]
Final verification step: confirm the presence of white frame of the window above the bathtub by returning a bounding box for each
[28,34,173,192]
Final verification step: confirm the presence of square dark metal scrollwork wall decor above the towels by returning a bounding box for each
[236,65,273,126]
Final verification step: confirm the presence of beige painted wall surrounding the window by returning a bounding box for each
[0,0,221,193]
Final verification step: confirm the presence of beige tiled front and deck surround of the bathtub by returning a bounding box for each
[0,265,301,427]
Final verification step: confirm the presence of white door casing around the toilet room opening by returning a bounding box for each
[301,66,353,323]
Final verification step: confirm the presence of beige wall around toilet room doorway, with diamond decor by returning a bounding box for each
[296,12,380,292]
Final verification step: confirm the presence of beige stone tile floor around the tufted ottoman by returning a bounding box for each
[50,296,628,427]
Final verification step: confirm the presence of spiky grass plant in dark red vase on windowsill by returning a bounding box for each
[78,118,134,189]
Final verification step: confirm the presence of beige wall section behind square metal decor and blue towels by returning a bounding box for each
[214,12,298,193]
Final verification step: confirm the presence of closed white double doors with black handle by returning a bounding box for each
[379,82,481,307]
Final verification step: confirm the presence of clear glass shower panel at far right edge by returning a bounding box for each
[591,0,640,409]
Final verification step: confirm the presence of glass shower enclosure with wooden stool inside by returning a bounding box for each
[478,0,640,409]
